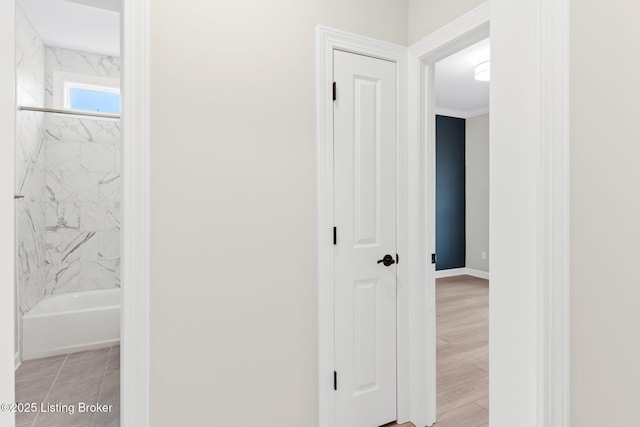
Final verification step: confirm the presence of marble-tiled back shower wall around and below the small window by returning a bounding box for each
[45,46,121,294]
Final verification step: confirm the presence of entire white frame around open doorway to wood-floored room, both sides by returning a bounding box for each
[408,0,569,427]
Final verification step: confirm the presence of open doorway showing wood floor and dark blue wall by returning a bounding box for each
[434,39,490,426]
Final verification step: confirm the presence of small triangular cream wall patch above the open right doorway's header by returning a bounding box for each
[408,0,487,44]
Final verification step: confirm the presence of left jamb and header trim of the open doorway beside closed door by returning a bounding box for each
[407,3,489,427]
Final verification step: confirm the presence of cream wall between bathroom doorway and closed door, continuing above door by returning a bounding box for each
[149,0,407,427]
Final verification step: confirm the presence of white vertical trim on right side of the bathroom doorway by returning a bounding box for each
[120,0,151,427]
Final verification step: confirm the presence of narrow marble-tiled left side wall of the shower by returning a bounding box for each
[15,7,47,314]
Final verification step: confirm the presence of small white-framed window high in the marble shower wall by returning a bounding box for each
[53,71,120,114]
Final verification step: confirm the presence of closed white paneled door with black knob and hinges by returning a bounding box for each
[333,50,397,427]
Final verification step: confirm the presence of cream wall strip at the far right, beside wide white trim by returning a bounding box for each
[570,0,640,427]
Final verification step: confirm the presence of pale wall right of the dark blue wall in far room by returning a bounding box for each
[465,114,489,272]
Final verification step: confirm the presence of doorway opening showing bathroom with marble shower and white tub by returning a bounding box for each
[15,0,122,426]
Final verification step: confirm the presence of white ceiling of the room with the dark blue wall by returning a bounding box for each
[435,39,490,118]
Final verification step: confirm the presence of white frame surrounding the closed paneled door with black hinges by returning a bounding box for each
[316,26,410,427]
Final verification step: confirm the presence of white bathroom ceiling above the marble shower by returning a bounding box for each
[16,0,121,56]
